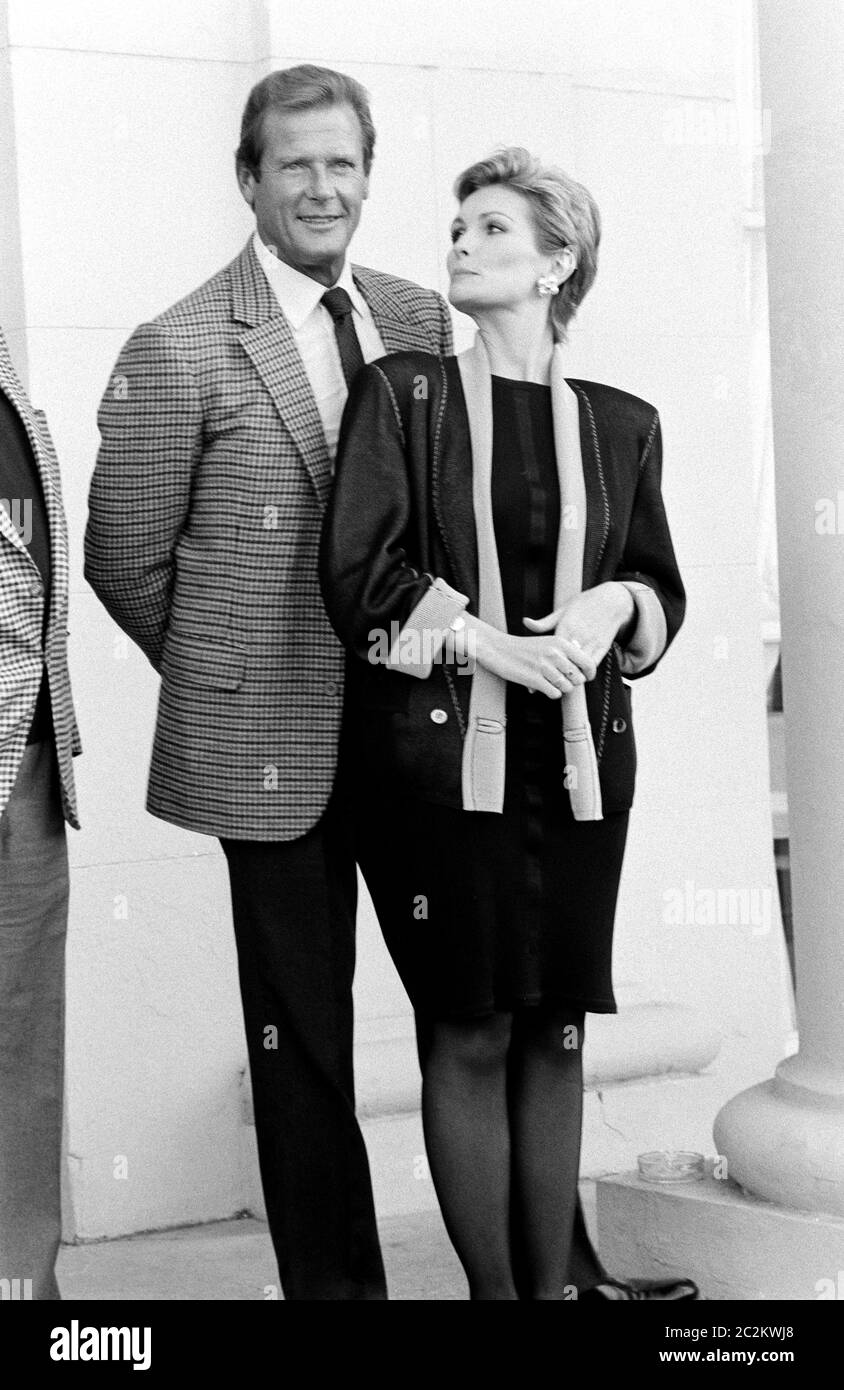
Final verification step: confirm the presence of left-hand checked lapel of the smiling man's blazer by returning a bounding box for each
[232,242,331,506]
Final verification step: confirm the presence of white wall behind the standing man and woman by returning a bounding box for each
[0,0,788,1237]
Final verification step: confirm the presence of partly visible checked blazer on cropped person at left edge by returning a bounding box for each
[0,329,82,828]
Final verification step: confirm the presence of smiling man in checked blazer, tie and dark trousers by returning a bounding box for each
[85,65,452,1300]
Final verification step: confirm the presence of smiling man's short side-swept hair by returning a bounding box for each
[235,63,375,179]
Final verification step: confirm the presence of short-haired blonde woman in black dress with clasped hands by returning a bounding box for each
[321,149,697,1300]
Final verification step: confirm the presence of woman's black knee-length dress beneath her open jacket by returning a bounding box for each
[353,377,628,1019]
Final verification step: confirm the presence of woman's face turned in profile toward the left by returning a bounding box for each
[446,183,555,314]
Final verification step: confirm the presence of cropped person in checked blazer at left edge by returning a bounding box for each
[0,322,81,1298]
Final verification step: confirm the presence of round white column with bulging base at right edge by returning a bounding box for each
[715,0,844,1215]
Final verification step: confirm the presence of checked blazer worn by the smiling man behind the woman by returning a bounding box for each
[85,243,452,841]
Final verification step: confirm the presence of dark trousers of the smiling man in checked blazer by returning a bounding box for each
[221,756,387,1300]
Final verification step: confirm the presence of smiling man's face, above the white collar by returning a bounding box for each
[238,106,370,285]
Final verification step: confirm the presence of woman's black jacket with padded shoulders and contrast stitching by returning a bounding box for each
[320,352,685,813]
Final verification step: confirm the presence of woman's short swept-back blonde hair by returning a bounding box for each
[455,145,601,338]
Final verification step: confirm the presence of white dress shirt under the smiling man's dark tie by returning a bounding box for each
[253,232,385,459]
